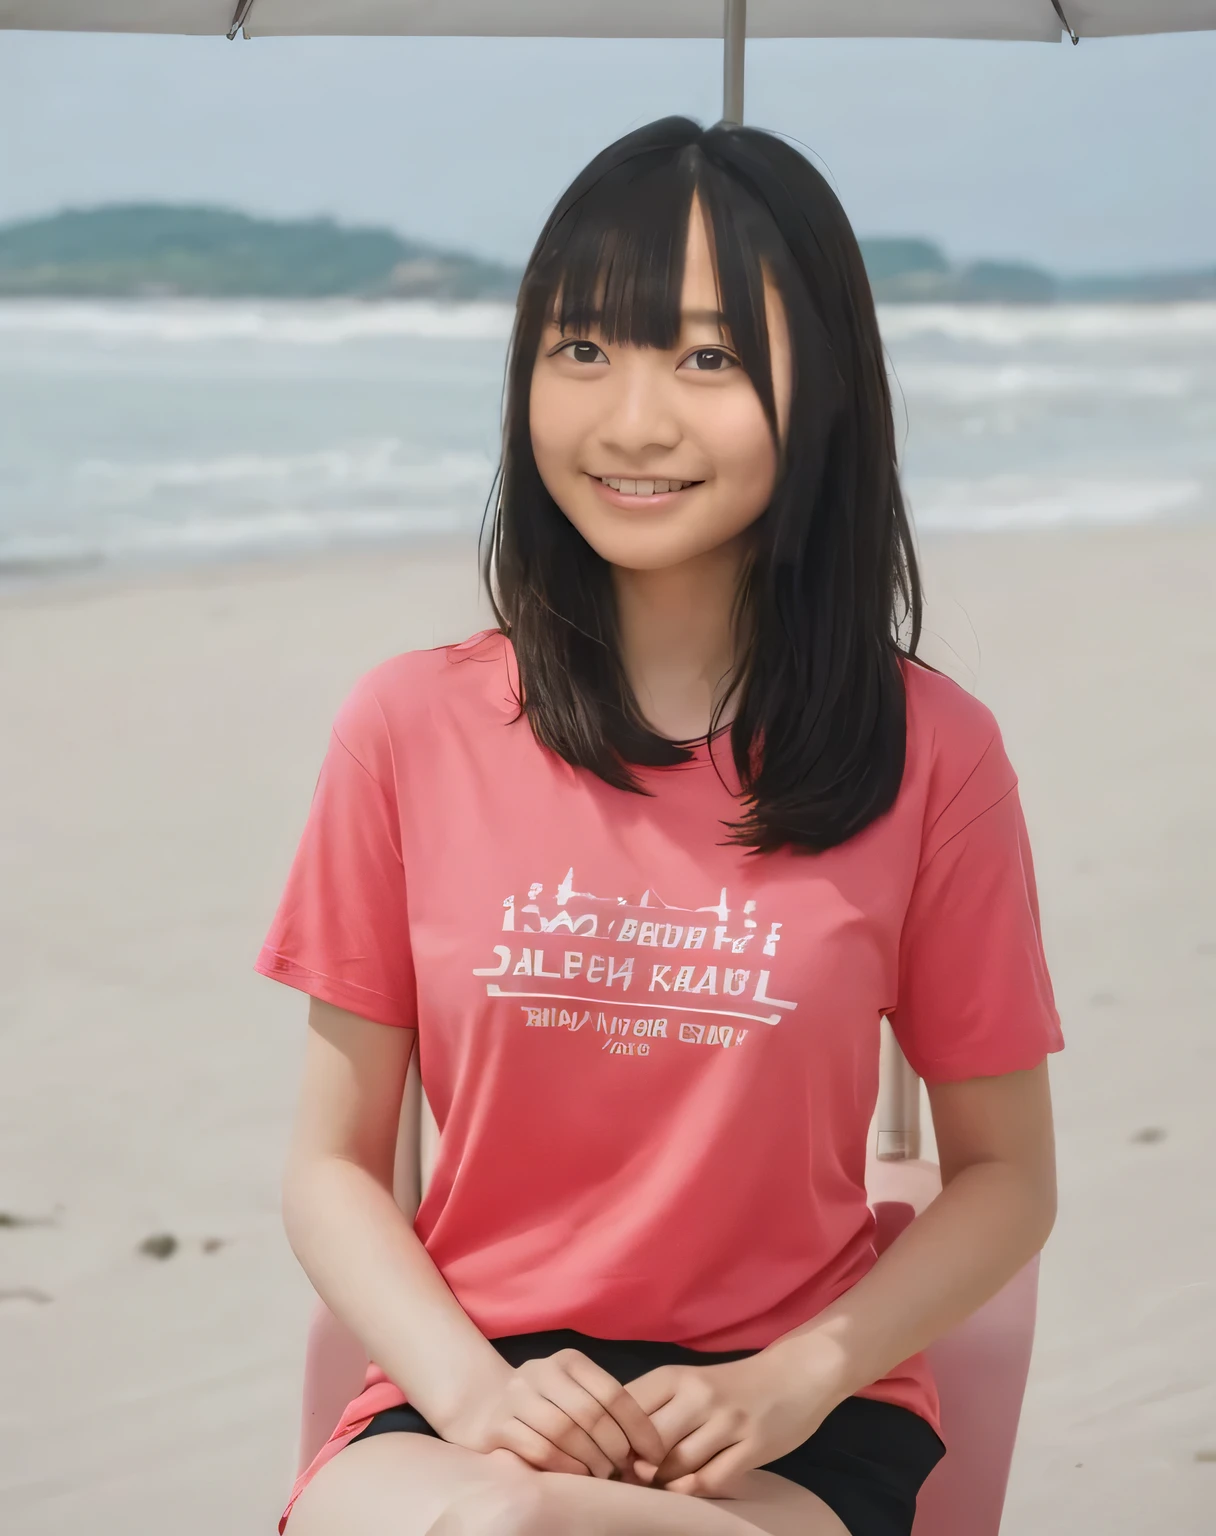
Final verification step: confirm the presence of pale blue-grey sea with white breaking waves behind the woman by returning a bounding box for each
[0,301,1216,584]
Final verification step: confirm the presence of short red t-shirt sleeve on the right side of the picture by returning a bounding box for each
[891,734,1064,1083]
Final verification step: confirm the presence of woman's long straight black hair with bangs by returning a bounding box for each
[484,117,921,852]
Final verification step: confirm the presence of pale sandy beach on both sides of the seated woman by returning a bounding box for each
[0,525,1216,1536]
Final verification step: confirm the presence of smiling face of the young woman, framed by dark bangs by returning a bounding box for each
[530,201,792,570]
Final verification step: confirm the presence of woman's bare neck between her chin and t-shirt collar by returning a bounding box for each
[613,542,743,740]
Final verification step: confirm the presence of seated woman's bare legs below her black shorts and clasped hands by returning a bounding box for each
[286,1435,848,1536]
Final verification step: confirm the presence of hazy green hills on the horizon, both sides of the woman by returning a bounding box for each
[0,203,1216,304]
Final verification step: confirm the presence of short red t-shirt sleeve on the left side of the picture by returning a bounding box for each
[255,677,415,1026]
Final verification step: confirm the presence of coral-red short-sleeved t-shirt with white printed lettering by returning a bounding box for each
[256,633,1062,1523]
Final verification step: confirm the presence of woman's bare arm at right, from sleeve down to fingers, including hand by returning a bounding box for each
[617,1063,1055,1499]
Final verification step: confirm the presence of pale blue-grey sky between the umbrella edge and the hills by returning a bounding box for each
[0,32,1216,272]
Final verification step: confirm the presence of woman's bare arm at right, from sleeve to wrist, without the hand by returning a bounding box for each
[763,1061,1056,1402]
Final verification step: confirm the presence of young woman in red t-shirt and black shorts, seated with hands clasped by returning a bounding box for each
[258,118,1061,1536]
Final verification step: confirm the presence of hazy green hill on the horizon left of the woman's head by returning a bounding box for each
[0,204,519,298]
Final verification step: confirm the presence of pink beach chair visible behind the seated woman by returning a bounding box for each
[299,1021,1038,1536]
